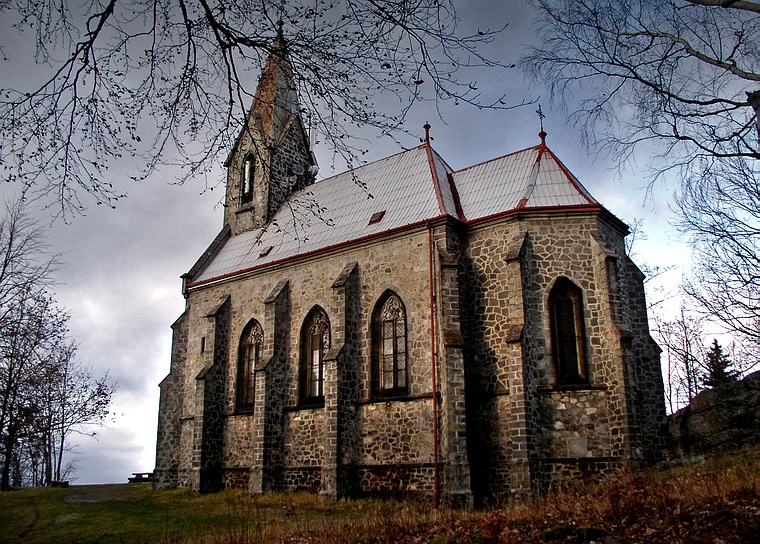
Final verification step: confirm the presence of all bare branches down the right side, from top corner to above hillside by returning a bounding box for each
[522,0,760,362]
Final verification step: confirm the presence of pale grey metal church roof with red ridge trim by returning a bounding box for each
[191,143,597,286]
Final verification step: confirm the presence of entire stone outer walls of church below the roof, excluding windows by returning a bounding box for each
[157,205,664,503]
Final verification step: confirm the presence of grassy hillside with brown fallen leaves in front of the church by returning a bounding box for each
[0,448,760,544]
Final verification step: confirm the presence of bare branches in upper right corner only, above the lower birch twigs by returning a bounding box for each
[522,0,760,168]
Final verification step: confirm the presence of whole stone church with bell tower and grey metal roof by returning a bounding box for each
[155,43,665,505]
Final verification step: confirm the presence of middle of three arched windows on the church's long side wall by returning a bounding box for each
[300,306,330,404]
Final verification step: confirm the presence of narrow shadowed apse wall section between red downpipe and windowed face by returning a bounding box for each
[461,222,529,501]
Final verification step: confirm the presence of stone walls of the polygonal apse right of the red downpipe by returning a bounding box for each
[462,210,661,496]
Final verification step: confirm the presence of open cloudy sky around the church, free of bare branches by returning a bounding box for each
[0,0,688,484]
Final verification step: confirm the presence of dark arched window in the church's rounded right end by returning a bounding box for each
[549,278,588,385]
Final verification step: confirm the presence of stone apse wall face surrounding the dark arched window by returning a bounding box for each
[525,216,629,470]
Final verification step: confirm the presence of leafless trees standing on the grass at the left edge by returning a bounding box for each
[0,203,113,490]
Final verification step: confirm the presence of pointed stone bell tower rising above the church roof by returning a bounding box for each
[224,31,317,236]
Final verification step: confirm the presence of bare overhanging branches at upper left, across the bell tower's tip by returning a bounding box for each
[0,0,524,214]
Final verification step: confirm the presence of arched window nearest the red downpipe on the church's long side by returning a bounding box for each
[372,291,408,395]
